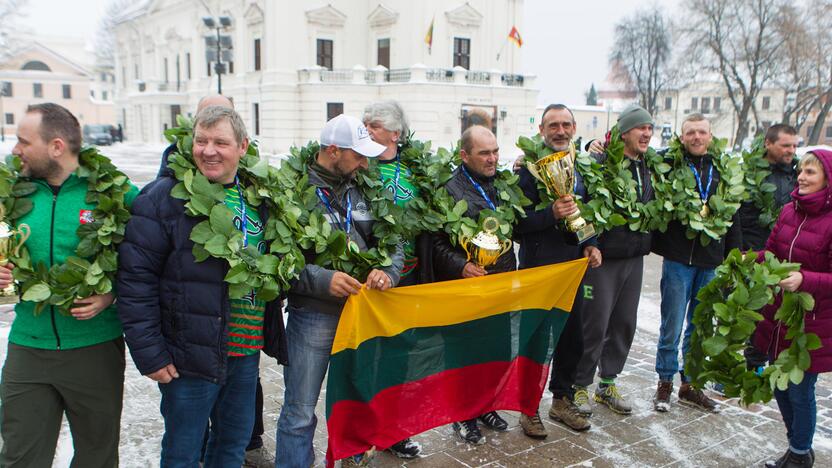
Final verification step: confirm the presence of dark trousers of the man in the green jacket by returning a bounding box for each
[0,337,124,468]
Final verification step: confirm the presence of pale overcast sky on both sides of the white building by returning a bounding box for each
[23,0,678,105]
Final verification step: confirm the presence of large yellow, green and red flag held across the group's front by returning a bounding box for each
[326,259,587,465]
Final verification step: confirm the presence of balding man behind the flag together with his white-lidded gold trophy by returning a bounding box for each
[433,125,517,445]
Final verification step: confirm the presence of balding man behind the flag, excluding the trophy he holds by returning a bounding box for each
[433,125,517,445]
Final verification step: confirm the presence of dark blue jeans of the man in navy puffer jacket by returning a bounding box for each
[159,352,260,468]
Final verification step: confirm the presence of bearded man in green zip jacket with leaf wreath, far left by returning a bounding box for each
[0,103,137,468]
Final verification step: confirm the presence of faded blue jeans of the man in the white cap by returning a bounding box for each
[275,304,339,468]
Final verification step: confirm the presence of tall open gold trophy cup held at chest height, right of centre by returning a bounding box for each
[526,142,595,243]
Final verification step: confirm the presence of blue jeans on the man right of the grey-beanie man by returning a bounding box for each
[656,259,714,382]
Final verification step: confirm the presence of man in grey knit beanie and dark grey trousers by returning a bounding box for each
[575,105,653,416]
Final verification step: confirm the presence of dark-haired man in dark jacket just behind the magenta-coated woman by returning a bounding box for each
[740,124,797,250]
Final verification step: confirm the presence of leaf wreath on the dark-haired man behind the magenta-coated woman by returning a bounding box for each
[742,135,782,230]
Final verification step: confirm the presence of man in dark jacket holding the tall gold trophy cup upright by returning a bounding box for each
[517,104,601,439]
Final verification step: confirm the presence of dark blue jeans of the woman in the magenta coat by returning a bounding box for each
[774,372,818,454]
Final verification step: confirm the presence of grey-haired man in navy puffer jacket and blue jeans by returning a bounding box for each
[118,106,285,467]
